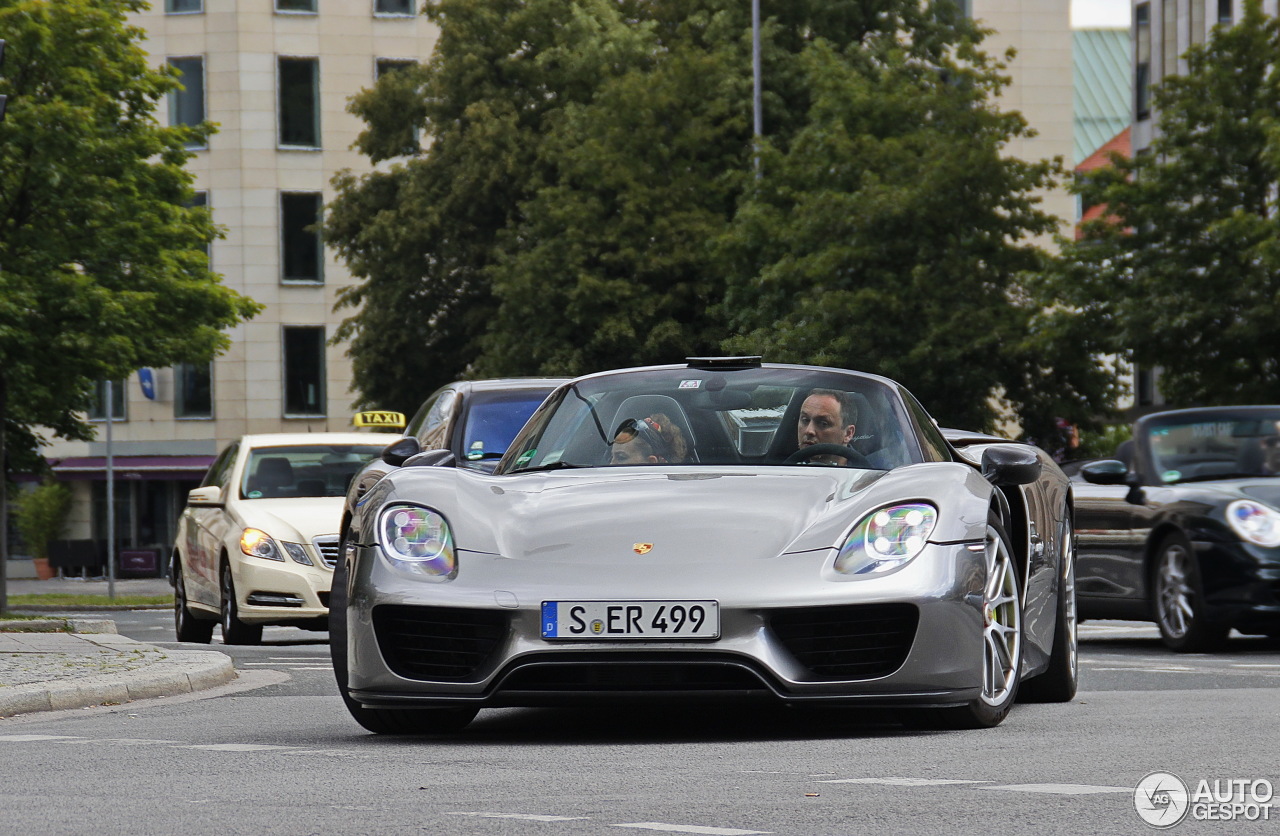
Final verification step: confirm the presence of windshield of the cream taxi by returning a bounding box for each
[241,444,385,499]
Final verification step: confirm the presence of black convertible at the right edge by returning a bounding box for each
[1075,406,1280,652]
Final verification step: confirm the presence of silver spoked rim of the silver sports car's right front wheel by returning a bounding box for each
[982,527,1023,705]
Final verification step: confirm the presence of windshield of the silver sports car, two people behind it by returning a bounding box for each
[498,367,922,474]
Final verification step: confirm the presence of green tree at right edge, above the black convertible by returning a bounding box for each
[1042,0,1280,406]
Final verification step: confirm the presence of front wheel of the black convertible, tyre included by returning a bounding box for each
[1151,534,1231,653]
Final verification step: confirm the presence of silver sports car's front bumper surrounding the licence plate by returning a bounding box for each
[347,544,986,707]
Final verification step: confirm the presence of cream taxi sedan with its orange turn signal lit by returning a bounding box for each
[170,433,399,644]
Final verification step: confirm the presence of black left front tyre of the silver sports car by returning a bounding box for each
[329,524,479,735]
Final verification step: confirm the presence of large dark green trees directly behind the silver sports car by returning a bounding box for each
[326,0,1097,426]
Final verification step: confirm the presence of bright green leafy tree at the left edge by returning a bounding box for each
[0,0,259,608]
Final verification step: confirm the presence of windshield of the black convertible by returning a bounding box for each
[1147,411,1280,484]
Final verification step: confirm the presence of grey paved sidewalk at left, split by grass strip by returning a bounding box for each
[0,579,236,718]
